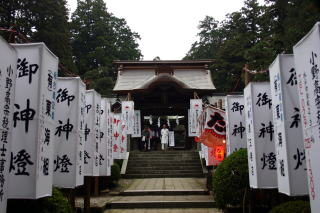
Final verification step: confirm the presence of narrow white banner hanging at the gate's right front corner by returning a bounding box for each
[190,99,202,136]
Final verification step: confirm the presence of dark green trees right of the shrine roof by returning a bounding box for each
[185,0,320,93]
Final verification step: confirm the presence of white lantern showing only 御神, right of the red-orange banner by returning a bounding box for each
[225,95,247,156]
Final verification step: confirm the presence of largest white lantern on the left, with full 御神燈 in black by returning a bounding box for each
[9,43,59,199]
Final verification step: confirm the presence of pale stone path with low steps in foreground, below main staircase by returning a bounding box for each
[76,178,221,213]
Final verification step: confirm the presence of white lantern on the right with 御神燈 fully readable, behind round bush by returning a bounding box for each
[244,82,277,188]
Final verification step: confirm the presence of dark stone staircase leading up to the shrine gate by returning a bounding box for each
[124,150,204,178]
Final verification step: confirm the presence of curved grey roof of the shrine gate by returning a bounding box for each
[113,60,215,93]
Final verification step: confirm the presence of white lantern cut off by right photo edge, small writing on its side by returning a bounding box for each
[293,22,320,213]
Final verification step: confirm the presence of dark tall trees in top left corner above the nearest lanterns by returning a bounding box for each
[0,0,75,71]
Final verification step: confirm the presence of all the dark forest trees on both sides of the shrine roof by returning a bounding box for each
[0,0,320,96]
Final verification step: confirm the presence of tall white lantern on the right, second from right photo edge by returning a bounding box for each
[269,55,308,196]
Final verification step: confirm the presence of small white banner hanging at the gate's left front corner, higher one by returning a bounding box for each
[121,101,134,134]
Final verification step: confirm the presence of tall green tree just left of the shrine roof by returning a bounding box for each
[71,0,142,95]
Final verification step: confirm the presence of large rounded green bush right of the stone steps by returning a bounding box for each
[213,149,249,208]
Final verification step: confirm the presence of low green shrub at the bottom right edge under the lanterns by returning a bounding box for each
[269,200,311,213]
